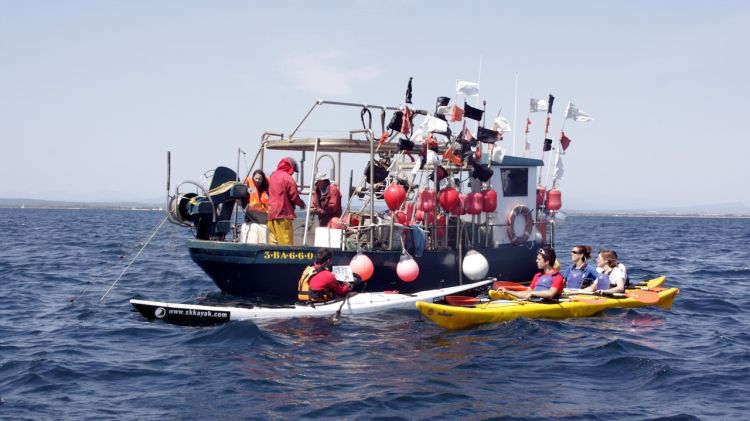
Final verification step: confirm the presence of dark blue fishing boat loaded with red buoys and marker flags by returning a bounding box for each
[167,93,560,299]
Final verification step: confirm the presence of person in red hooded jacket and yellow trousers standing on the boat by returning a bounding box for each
[268,158,305,246]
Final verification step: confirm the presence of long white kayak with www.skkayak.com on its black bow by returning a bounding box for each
[130,279,494,325]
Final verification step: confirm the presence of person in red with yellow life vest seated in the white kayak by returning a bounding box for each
[297,248,362,302]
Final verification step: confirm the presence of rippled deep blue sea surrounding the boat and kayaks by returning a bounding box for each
[0,209,750,420]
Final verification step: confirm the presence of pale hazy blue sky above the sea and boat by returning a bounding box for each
[0,0,750,209]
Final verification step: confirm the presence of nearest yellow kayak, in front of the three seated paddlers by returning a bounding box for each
[416,278,679,329]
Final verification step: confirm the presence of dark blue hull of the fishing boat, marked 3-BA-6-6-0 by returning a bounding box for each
[188,240,538,299]
